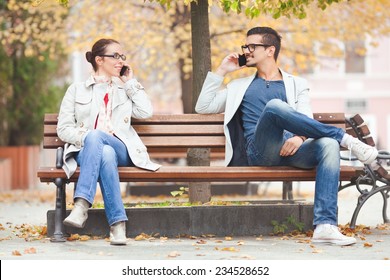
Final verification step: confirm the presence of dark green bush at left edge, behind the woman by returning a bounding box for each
[0,46,65,146]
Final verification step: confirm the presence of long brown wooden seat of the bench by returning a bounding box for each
[38,166,359,182]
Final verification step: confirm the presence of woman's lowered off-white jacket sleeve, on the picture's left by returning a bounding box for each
[57,84,88,148]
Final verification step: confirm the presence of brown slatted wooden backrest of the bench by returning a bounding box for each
[43,113,362,153]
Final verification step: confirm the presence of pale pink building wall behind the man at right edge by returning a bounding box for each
[306,38,390,150]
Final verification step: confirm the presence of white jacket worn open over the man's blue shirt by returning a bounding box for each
[195,70,313,165]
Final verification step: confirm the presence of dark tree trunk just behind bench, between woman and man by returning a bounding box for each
[187,0,211,203]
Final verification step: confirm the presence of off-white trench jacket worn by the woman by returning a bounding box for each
[57,76,160,178]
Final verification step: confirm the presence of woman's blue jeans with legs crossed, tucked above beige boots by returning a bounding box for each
[74,130,133,226]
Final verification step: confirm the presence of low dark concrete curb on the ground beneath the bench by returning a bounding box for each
[47,202,313,237]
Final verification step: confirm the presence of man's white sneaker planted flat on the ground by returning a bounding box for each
[312,224,356,246]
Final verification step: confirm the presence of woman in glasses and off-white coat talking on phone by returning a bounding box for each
[57,39,160,245]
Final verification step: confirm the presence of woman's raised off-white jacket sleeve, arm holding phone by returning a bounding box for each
[125,79,153,119]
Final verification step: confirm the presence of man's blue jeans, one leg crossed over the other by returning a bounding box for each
[247,99,345,225]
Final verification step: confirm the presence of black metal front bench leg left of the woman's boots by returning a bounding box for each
[50,178,66,242]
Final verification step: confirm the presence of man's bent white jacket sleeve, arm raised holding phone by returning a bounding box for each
[195,72,227,114]
